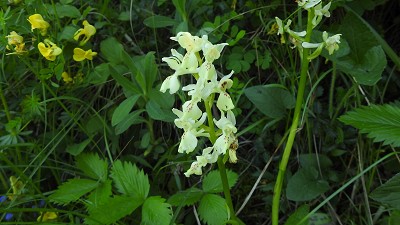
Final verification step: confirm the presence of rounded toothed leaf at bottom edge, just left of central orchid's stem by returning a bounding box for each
[198,194,229,225]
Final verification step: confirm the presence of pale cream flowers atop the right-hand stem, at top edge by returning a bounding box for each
[275,0,341,60]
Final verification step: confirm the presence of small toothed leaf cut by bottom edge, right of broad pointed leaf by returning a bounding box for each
[141,196,172,225]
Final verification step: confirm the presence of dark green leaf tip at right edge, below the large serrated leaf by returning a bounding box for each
[370,173,400,210]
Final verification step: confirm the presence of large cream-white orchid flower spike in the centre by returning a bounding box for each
[160,32,238,177]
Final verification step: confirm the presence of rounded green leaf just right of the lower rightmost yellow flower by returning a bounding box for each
[100,37,125,64]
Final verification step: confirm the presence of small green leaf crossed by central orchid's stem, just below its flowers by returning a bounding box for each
[203,170,238,193]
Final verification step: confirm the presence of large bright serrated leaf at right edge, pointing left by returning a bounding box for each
[339,104,400,147]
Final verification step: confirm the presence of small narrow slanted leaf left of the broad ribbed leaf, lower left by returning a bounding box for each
[86,180,112,211]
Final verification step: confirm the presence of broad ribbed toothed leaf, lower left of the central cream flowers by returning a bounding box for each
[111,160,150,201]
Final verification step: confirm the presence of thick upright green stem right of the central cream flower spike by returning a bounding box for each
[272,9,314,225]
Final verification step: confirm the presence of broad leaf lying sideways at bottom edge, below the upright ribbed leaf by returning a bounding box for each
[85,196,143,225]
